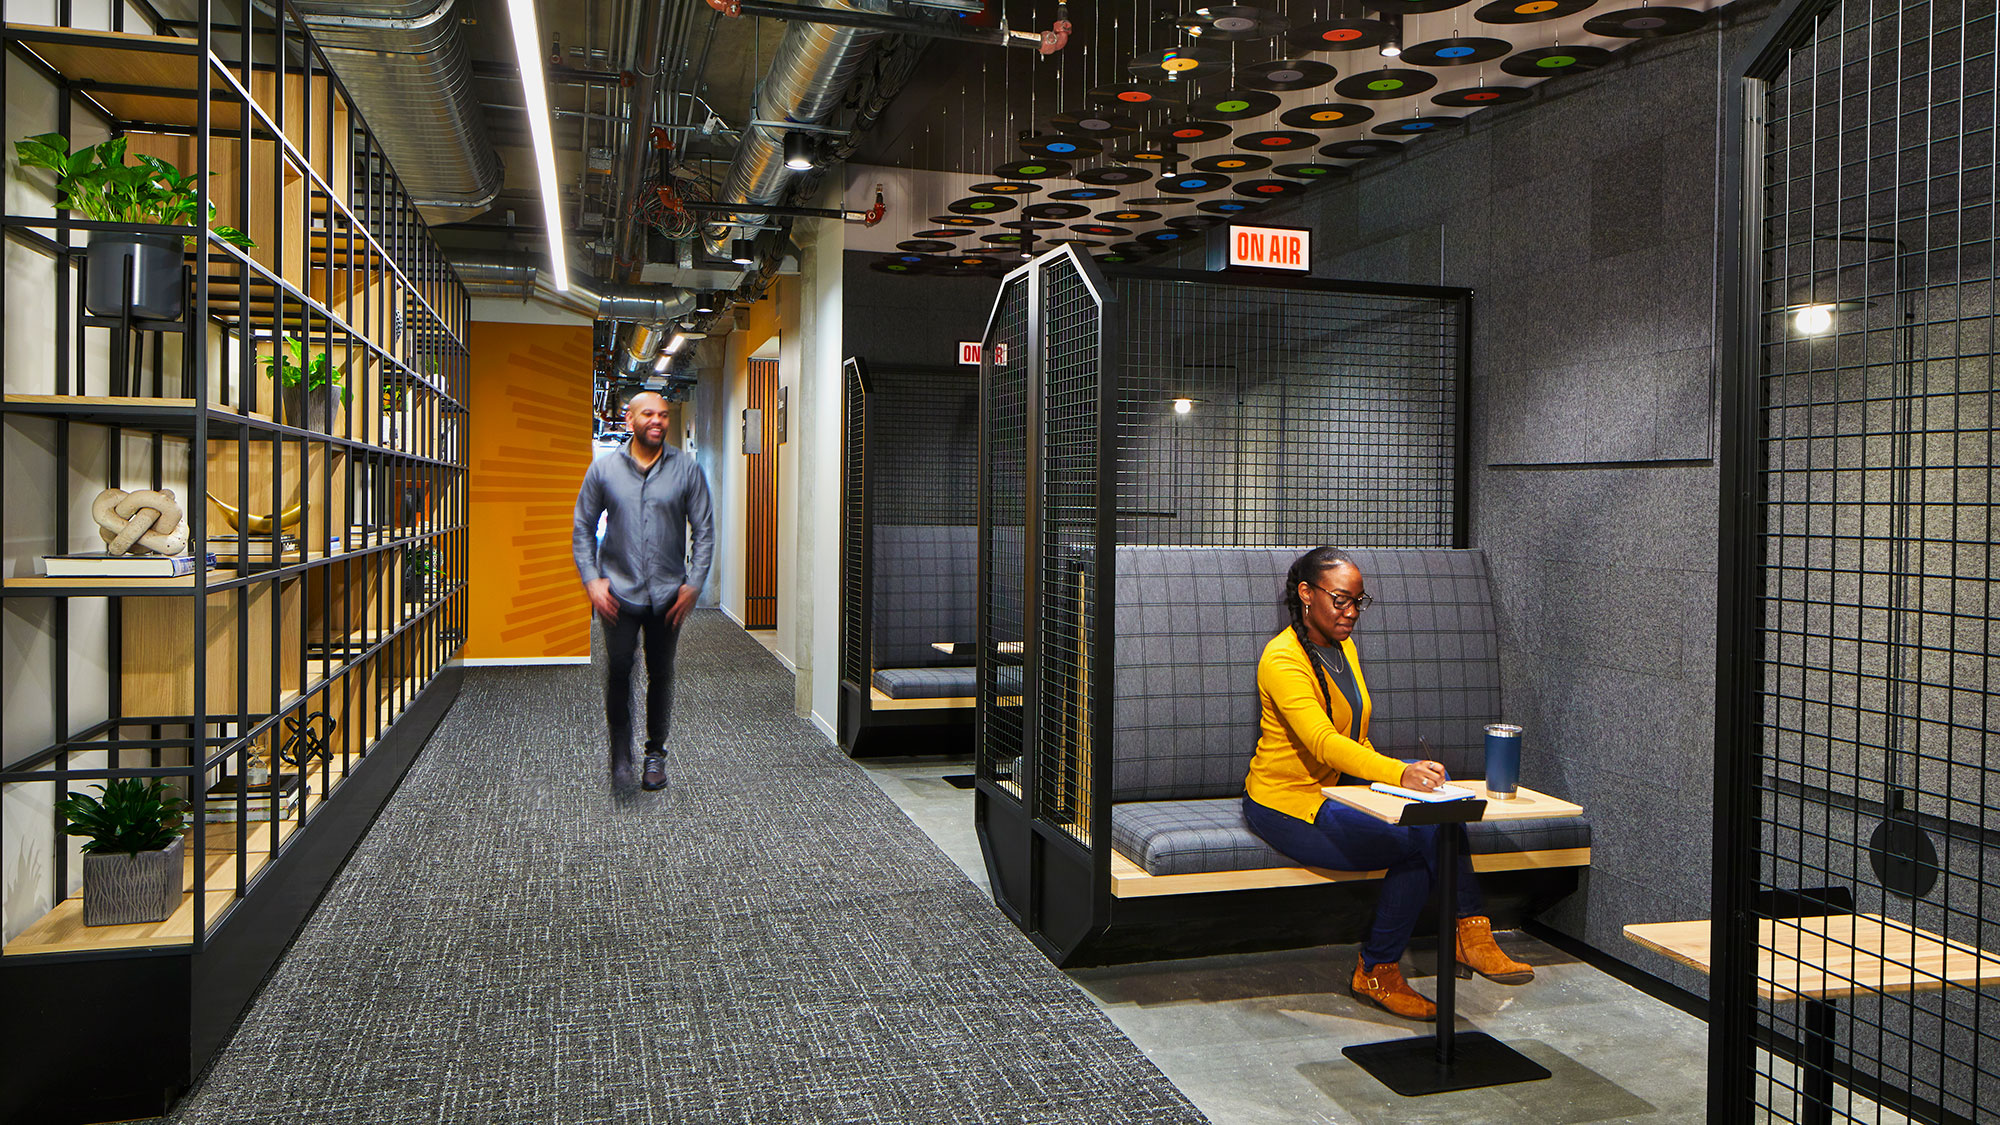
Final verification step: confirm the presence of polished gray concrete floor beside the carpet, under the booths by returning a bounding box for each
[862,759,1708,1125]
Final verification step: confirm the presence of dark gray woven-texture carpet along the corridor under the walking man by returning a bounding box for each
[172,611,1202,1125]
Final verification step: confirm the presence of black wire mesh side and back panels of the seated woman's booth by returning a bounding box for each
[978,250,1468,957]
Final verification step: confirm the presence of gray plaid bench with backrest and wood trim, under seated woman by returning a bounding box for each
[1110,546,1590,897]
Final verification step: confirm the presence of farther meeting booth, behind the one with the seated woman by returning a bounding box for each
[840,356,978,757]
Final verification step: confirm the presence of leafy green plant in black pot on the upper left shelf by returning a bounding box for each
[14,132,256,320]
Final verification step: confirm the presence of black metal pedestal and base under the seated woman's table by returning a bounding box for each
[1340,801,1548,1097]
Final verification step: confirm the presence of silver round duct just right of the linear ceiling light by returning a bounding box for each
[702,0,888,258]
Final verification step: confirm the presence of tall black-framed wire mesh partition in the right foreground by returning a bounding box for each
[1712,0,2000,1121]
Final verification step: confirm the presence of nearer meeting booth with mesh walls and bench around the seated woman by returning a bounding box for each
[974,248,1590,965]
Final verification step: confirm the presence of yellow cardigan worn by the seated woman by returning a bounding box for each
[1244,629,1404,823]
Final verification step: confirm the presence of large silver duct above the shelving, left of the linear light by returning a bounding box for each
[294,0,502,222]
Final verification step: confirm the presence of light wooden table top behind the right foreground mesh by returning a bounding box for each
[1624,915,2000,1001]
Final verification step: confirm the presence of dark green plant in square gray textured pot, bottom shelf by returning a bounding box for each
[56,777,188,925]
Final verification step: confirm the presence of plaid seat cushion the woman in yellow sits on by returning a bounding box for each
[1112,797,1590,875]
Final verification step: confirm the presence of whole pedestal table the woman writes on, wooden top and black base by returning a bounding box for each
[1322,781,1584,1097]
